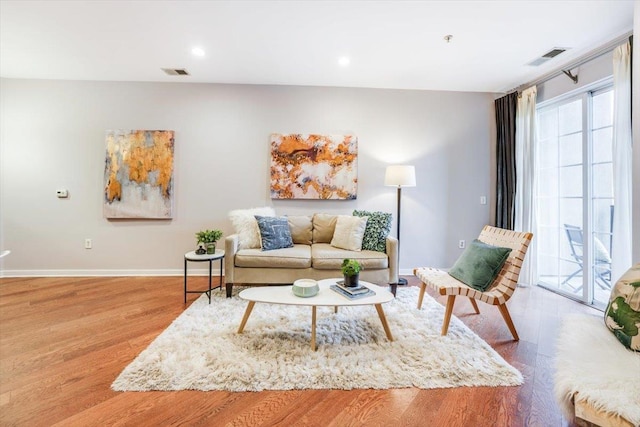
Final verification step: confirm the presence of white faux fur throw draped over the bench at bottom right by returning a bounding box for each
[555,314,640,426]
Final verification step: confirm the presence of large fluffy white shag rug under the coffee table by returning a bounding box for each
[111,287,523,391]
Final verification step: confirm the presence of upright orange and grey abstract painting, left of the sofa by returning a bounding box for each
[103,130,174,219]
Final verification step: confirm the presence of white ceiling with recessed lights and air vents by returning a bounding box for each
[0,0,634,92]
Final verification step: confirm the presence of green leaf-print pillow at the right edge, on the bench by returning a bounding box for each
[604,264,640,351]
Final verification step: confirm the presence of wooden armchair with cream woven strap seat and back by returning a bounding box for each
[413,225,533,341]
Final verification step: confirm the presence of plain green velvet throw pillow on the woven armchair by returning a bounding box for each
[449,239,511,292]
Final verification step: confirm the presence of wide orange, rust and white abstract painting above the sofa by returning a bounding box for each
[270,134,358,200]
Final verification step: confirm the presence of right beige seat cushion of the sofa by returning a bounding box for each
[311,243,389,270]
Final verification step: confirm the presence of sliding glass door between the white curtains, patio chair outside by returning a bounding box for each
[537,85,614,307]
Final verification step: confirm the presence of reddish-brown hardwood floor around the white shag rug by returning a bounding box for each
[0,277,601,427]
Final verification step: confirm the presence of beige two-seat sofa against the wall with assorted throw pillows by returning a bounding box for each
[224,214,398,297]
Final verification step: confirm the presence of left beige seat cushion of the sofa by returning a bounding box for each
[235,245,311,268]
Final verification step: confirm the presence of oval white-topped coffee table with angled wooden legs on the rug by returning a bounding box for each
[238,279,393,351]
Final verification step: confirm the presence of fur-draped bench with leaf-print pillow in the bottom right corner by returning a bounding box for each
[555,264,640,427]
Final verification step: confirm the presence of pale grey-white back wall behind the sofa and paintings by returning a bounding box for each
[0,79,495,276]
